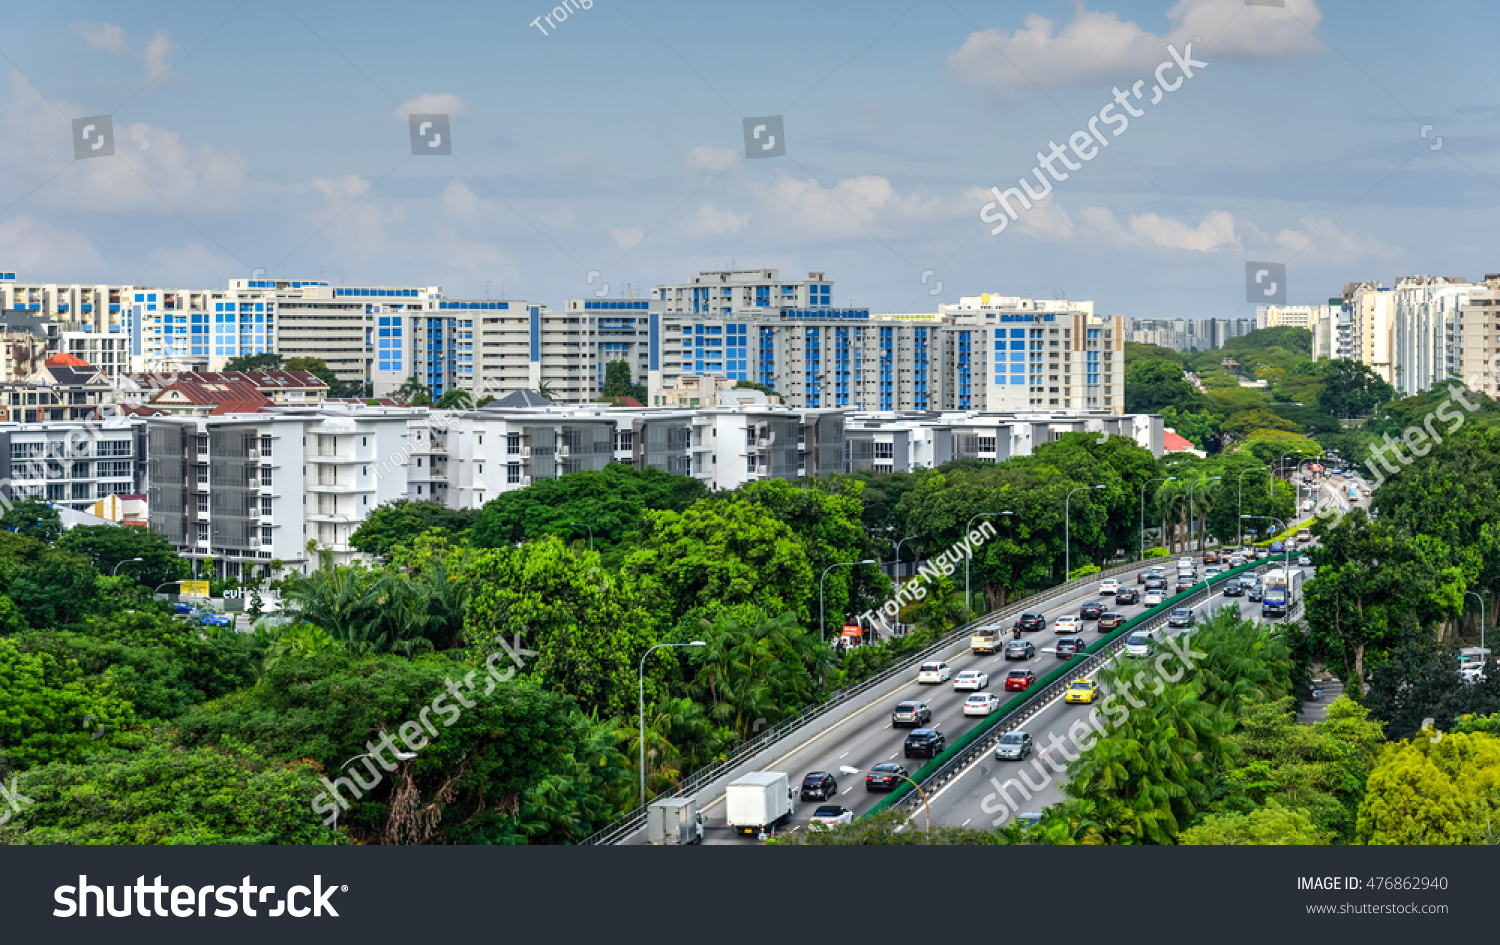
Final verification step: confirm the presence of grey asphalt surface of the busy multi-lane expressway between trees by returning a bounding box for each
[704,560,1308,843]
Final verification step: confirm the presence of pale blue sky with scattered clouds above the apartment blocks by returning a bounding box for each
[0,0,1500,317]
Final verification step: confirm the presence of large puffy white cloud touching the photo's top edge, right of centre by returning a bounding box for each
[948,0,1323,99]
